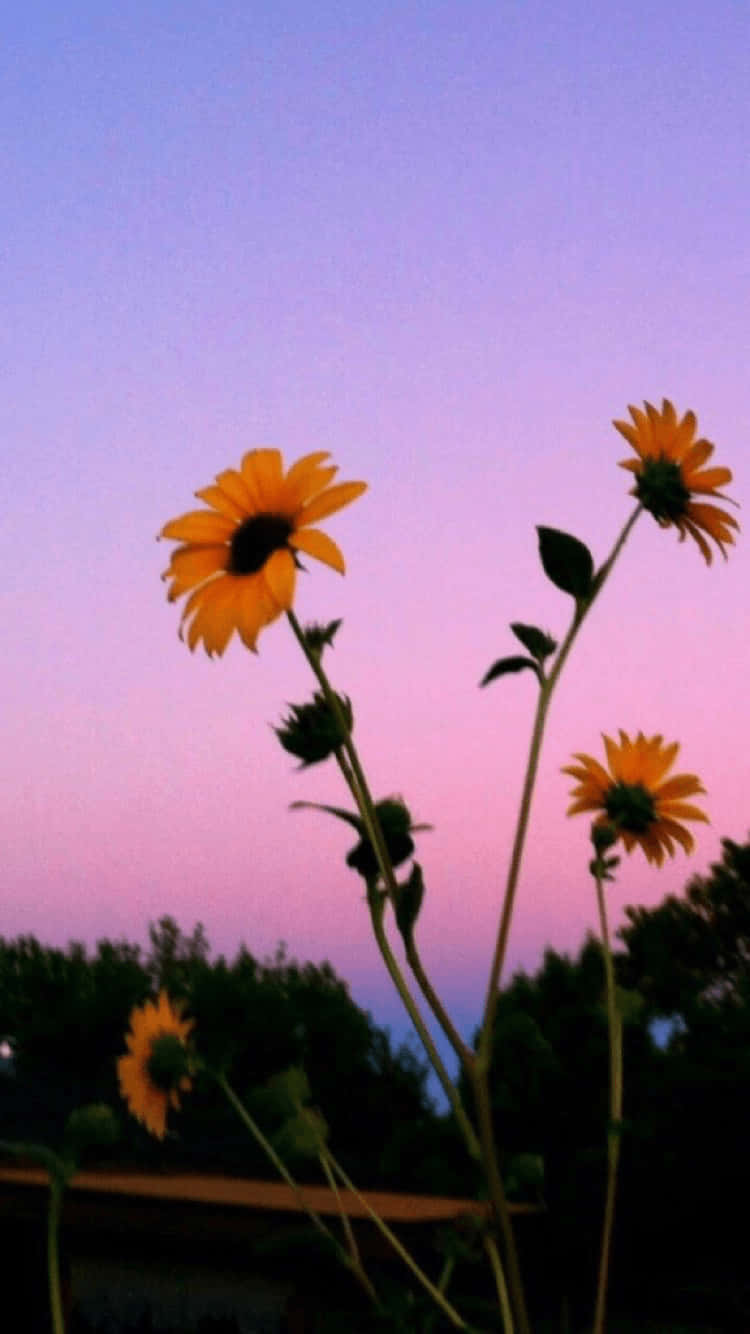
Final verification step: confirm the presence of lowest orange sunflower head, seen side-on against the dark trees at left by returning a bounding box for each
[117,991,194,1139]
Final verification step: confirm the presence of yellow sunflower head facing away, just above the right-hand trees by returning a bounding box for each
[563,731,707,866]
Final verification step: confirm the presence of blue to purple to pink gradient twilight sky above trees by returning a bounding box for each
[0,0,750,1072]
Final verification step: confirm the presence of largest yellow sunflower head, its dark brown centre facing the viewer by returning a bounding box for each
[159,450,367,656]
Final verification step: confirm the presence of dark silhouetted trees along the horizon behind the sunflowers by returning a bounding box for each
[0,839,750,1329]
